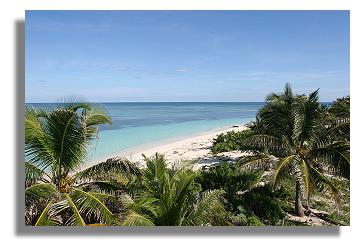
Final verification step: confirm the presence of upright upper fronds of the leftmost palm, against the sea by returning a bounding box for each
[25,103,111,180]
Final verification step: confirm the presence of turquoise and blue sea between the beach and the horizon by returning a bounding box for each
[30,102,264,160]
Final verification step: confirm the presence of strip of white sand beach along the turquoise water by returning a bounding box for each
[86,124,247,169]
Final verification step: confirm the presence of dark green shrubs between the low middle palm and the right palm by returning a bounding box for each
[197,163,287,226]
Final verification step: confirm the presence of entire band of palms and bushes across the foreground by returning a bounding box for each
[24,84,350,226]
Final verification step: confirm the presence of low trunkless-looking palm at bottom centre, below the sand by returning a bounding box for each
[123,154,228,226]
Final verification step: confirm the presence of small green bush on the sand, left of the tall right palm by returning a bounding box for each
[211,130,253,154]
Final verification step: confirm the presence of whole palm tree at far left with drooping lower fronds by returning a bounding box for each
[25,103,138,226]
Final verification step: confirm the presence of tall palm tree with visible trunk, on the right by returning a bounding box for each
[240,84,350,216]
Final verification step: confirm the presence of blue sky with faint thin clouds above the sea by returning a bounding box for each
[25,11,350,102]
